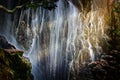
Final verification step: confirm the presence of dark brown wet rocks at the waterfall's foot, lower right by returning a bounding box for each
[71,50,120,80]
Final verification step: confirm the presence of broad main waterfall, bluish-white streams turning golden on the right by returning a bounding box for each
[0,0,108,80]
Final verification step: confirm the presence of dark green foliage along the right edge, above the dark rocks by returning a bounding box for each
[109,1,120,51]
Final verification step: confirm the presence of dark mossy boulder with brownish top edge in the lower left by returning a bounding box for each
[0,36,33,80]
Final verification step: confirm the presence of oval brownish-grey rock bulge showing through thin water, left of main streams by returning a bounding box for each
[16,21,33,49]
